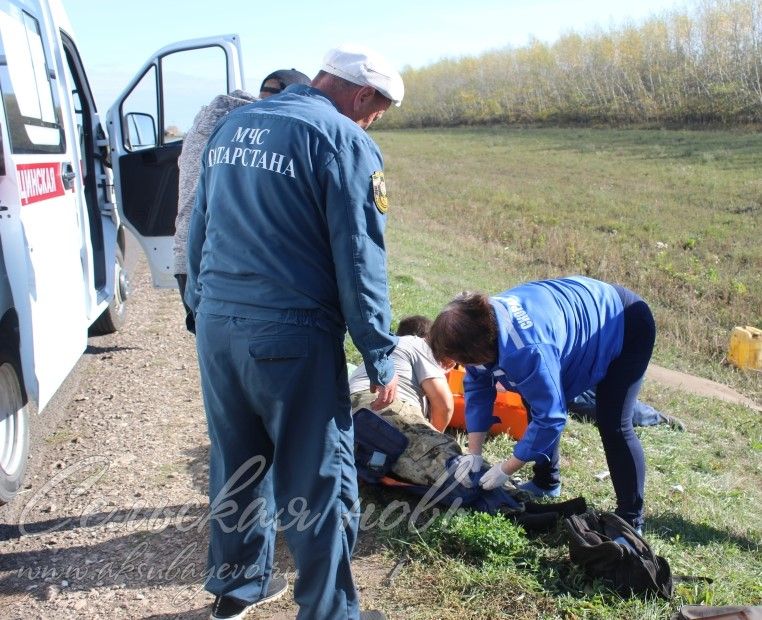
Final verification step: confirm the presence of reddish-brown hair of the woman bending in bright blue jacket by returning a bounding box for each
[428,292,497,364]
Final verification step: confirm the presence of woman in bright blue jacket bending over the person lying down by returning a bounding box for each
[429,276,656,528]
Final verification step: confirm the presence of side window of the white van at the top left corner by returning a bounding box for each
[0,11,66,153]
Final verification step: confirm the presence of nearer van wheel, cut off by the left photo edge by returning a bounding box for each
[0,352,29,505]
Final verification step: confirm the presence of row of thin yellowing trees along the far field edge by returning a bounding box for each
[380,0,762,128]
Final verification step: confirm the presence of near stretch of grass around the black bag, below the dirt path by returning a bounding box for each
[366,386,762,620]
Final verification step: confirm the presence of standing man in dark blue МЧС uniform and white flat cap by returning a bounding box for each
[186,47,404,620]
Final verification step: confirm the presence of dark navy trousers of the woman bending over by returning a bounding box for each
[533,286,656,527]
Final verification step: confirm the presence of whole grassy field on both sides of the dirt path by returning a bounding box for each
[354,128,762,620]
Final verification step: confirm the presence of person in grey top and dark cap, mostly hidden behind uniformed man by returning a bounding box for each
[174,69,310,331]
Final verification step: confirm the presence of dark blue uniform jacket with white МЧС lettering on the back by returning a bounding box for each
[186,85,396,385]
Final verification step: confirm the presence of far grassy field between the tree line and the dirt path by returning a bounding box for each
[374,127,762,400]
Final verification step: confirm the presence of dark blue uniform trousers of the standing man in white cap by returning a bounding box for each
[196,309,359,620]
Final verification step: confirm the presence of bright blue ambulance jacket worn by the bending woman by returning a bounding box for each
[464,276,624,461]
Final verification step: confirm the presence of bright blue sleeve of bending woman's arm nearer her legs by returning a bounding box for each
[500,344,567,462]
